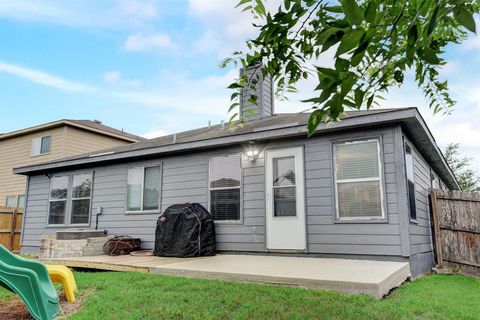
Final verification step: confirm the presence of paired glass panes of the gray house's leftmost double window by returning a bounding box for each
[48,172,93,225]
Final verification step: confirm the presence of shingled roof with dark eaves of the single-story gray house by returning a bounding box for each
[14,108,458,189]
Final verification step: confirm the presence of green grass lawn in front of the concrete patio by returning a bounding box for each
[0,272,480,320]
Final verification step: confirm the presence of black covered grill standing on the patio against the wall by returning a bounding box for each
[153,203,215,257]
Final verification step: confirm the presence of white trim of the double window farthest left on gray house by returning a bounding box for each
[46,171,94,228]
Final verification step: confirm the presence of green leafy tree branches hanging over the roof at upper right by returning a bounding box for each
[230,0,480,135]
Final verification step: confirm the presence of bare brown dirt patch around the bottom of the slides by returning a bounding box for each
[0,290,94,320]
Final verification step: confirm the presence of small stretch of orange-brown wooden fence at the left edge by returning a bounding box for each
[0,207,23,252]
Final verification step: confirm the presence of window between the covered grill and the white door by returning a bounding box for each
[209,156,242,221]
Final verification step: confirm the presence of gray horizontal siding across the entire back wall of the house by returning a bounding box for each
[22,126,408,256]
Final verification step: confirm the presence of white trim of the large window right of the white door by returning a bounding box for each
[332,138,386,222]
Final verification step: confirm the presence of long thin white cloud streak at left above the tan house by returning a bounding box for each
[0,61,96,92]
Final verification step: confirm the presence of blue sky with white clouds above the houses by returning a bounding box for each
[0,0,480,171]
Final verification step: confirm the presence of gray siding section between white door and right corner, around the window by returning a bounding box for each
[305,128,402,255]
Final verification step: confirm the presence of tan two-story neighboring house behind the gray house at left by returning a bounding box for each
[0,120,144,207]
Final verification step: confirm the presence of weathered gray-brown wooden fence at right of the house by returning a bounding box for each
[430,190,480,275]
